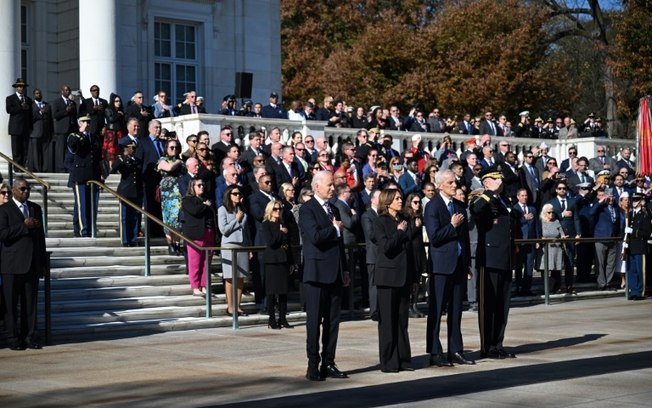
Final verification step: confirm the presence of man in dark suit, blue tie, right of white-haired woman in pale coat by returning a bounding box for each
[550,179,582,294]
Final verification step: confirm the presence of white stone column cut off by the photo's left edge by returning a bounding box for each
[0,0,20,159]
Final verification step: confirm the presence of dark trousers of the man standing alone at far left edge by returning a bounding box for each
[2,271,38,346]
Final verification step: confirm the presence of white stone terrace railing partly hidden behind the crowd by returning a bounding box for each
[160,114,636,161]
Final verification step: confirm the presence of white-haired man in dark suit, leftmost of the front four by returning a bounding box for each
[299,171,350,381]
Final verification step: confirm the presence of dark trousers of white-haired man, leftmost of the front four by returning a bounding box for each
[304,279,342,369]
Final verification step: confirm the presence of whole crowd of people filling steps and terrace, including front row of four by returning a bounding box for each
[5,77,651,372]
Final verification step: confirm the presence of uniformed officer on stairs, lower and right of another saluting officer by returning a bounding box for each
[111,142,143,247]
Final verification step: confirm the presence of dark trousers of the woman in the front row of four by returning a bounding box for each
[377,285,412,371]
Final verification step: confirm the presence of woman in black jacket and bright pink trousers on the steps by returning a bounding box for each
[181,179,215,297]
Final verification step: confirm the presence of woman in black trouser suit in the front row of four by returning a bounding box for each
[374,189,417,373]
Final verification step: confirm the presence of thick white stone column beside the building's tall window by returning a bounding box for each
[79,0,118,100]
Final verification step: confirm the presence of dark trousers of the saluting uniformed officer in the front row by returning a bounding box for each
[478,267,512,353]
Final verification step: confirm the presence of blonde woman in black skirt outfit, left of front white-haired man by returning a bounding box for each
[262,200,293,329]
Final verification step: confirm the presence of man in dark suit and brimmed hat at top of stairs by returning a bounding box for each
[5,78,32,166]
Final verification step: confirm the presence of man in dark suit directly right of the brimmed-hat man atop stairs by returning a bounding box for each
[27,88,52,172]
